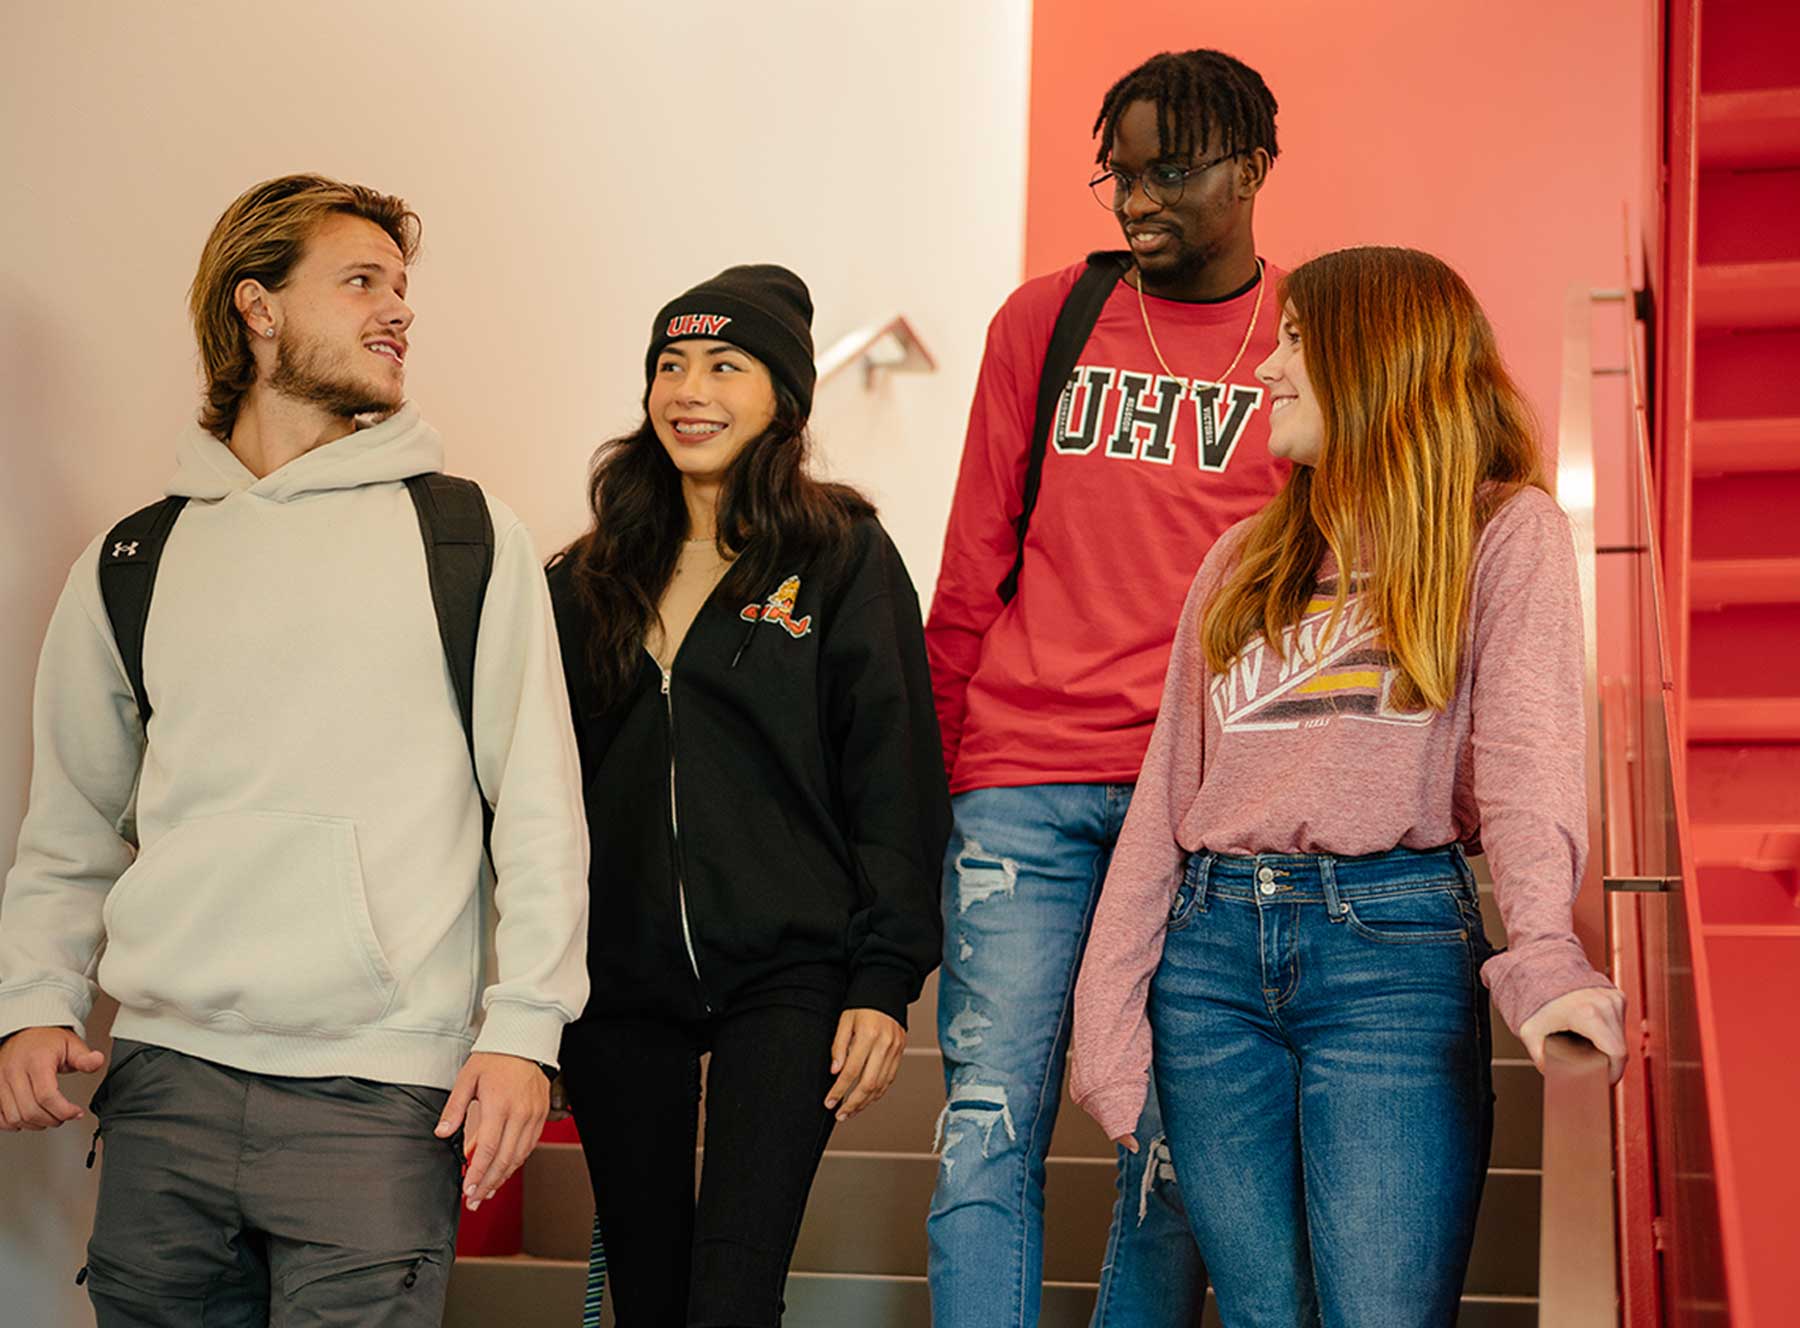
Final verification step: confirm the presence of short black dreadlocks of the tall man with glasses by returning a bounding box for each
[1093,50,1280,166]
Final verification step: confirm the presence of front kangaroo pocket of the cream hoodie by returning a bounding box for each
[99,812,394,1035]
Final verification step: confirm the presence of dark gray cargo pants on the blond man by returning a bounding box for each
[86,1040,463,1328]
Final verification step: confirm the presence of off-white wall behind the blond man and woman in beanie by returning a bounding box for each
[0,0,1030,1326]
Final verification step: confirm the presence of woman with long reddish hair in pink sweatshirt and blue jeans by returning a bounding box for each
[1073,248,1624,1328]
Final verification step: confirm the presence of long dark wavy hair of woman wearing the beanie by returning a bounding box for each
[562,381,875,709]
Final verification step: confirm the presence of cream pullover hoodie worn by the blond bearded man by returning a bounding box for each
[0,405,587,1087]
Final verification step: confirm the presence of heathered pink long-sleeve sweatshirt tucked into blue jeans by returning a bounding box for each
[1071,489,1609,1139]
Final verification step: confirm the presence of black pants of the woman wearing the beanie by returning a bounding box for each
[562,1006,839,1328]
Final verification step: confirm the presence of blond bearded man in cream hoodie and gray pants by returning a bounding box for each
[0,176,587,1328]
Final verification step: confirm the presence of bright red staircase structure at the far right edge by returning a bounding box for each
[1649,0,1800,1328]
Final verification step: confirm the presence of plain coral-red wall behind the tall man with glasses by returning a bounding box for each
[1026,0,1654,444]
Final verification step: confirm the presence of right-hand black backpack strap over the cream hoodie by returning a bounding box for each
[407,473,493,862]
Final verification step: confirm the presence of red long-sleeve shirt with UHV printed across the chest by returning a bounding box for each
[925,263,1287,794]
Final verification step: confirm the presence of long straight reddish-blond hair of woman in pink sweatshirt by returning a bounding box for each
[1201,247,1550,711]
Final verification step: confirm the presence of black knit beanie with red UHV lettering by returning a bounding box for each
[644,263,819,416]
